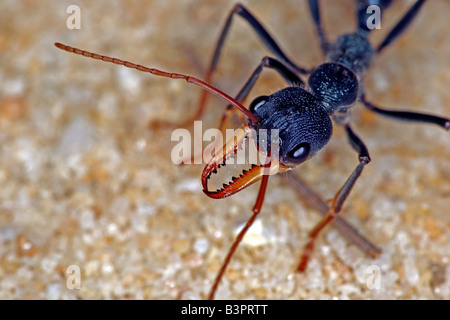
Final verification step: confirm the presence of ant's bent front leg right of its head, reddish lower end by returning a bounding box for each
[298,124,370,272]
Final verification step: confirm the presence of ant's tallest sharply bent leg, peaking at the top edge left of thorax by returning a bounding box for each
[173,3,310,126]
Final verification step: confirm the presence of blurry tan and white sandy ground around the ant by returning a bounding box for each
[0,0,450,299]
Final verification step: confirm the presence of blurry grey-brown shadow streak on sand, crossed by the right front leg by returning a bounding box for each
[286,171,381,258]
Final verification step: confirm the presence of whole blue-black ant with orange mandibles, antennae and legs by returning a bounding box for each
[55,0,450,299]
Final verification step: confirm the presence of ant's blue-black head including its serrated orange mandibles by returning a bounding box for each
[202,87,333,198]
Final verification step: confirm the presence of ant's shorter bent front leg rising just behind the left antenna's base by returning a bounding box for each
[182,56,305,163]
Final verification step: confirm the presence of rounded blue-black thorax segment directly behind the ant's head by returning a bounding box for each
[308,63,359,114]
